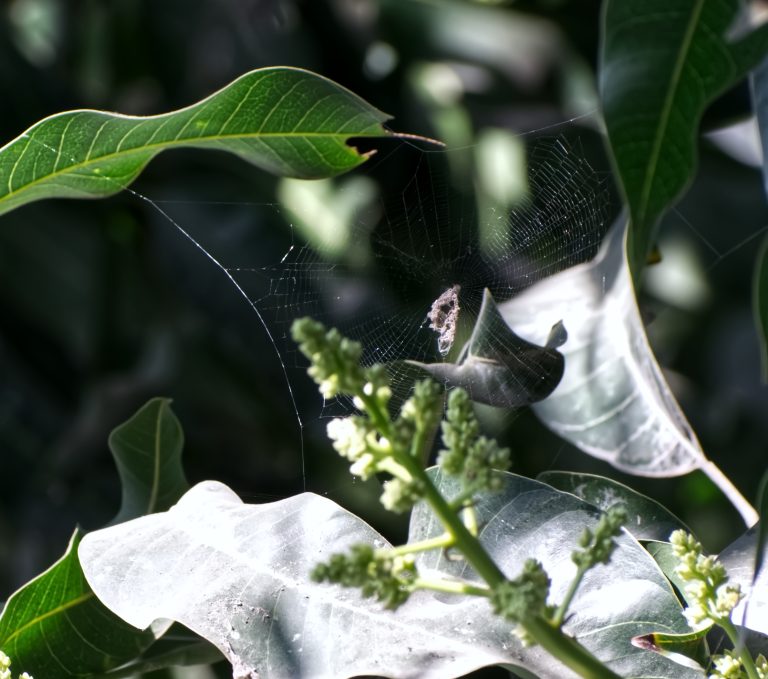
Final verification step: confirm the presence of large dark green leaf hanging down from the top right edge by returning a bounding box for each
[599,0,768,278]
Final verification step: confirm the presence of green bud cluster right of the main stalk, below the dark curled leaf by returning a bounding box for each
[437,389,510,492]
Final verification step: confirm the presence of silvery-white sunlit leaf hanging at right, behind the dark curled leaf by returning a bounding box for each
[499,224,705,476]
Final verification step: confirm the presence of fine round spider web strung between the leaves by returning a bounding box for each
[228,139,608,416]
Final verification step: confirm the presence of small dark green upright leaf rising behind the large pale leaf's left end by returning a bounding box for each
[109,398,189,523]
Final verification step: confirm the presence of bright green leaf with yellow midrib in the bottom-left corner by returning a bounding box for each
[0,531,155,679]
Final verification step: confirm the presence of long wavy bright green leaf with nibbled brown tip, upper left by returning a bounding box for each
[0,67,389,214]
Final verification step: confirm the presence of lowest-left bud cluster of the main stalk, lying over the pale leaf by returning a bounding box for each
[312,544,417,609]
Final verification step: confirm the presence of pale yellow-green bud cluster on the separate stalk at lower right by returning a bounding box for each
[669,530,744,627]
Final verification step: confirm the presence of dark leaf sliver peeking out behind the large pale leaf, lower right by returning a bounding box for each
[538,471,690,540]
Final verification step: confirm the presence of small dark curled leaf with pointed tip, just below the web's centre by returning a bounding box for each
[397,288,564,408]
